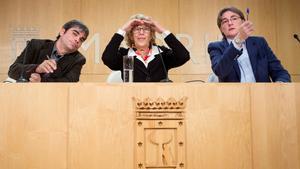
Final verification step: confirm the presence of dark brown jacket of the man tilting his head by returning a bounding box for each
[8,39,86,82]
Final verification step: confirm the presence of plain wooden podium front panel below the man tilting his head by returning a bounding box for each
[0,84,68,169]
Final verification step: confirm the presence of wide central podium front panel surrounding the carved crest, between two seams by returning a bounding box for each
[68,84,252,169]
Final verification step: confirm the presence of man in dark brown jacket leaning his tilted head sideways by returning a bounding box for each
[8,20,89,82]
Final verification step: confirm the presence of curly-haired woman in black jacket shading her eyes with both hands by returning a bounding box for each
[102,14,190,82]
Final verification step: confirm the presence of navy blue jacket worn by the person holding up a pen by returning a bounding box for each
[208,37,291,82]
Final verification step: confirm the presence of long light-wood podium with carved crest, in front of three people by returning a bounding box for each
[0,83,300,169]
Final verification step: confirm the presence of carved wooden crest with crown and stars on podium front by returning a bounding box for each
[133,97,187,169]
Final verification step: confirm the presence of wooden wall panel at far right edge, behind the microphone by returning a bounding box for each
[274,0,300,74]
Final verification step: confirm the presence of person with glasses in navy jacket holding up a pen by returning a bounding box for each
[208,7,291,82]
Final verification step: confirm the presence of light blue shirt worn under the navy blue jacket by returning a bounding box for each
[227,39,256,83]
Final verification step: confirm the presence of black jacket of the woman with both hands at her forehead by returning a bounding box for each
[102,33,190,82]
